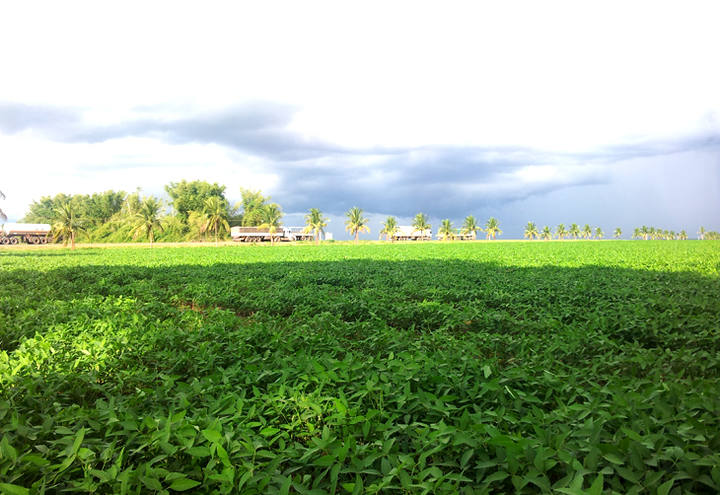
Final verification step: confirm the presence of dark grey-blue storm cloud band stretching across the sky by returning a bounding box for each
[0,102,720,216]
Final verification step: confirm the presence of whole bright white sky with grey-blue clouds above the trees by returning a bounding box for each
[0,1,720,239]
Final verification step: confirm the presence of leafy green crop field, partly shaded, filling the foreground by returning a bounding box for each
[0,241,720,494]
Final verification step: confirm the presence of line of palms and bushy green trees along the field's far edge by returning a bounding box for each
[0,185,720,247]
